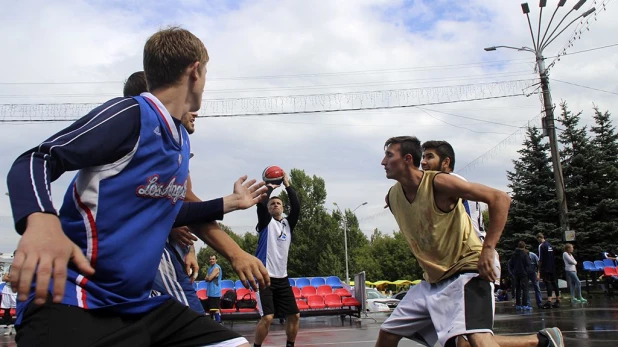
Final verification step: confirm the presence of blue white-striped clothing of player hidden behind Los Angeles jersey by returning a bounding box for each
[152,243,205,314]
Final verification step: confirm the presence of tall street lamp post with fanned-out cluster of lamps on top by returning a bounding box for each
[485,0,595,241]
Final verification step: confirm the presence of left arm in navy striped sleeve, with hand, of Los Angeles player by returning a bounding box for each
[7,98,140,305]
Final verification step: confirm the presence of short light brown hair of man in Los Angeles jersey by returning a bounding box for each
[144,27,209,91]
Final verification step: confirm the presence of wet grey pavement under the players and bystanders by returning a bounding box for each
[0,295,618,347]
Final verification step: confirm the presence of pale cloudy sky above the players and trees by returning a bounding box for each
[0,0,618,252]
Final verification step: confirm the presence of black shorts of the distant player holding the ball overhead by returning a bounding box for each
[257,277,300,317]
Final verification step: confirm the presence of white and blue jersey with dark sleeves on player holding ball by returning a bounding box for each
[256,187,300,278]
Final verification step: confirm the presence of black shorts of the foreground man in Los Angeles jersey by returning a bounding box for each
[15,299,241,347]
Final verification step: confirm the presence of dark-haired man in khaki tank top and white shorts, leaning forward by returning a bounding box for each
[376,136,564,347]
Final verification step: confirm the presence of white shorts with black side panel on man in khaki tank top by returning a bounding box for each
[380,273,494,347]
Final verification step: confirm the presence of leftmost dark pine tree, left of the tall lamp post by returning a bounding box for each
[498,128,562,268]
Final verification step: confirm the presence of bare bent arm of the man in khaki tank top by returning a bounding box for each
[434,174,511,282]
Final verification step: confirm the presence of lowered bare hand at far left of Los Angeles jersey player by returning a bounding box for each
[10,212,94,305]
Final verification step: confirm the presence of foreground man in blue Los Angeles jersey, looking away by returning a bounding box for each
[7,28,269,346]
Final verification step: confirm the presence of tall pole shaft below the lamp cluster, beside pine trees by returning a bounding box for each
[536,51,569,237]
